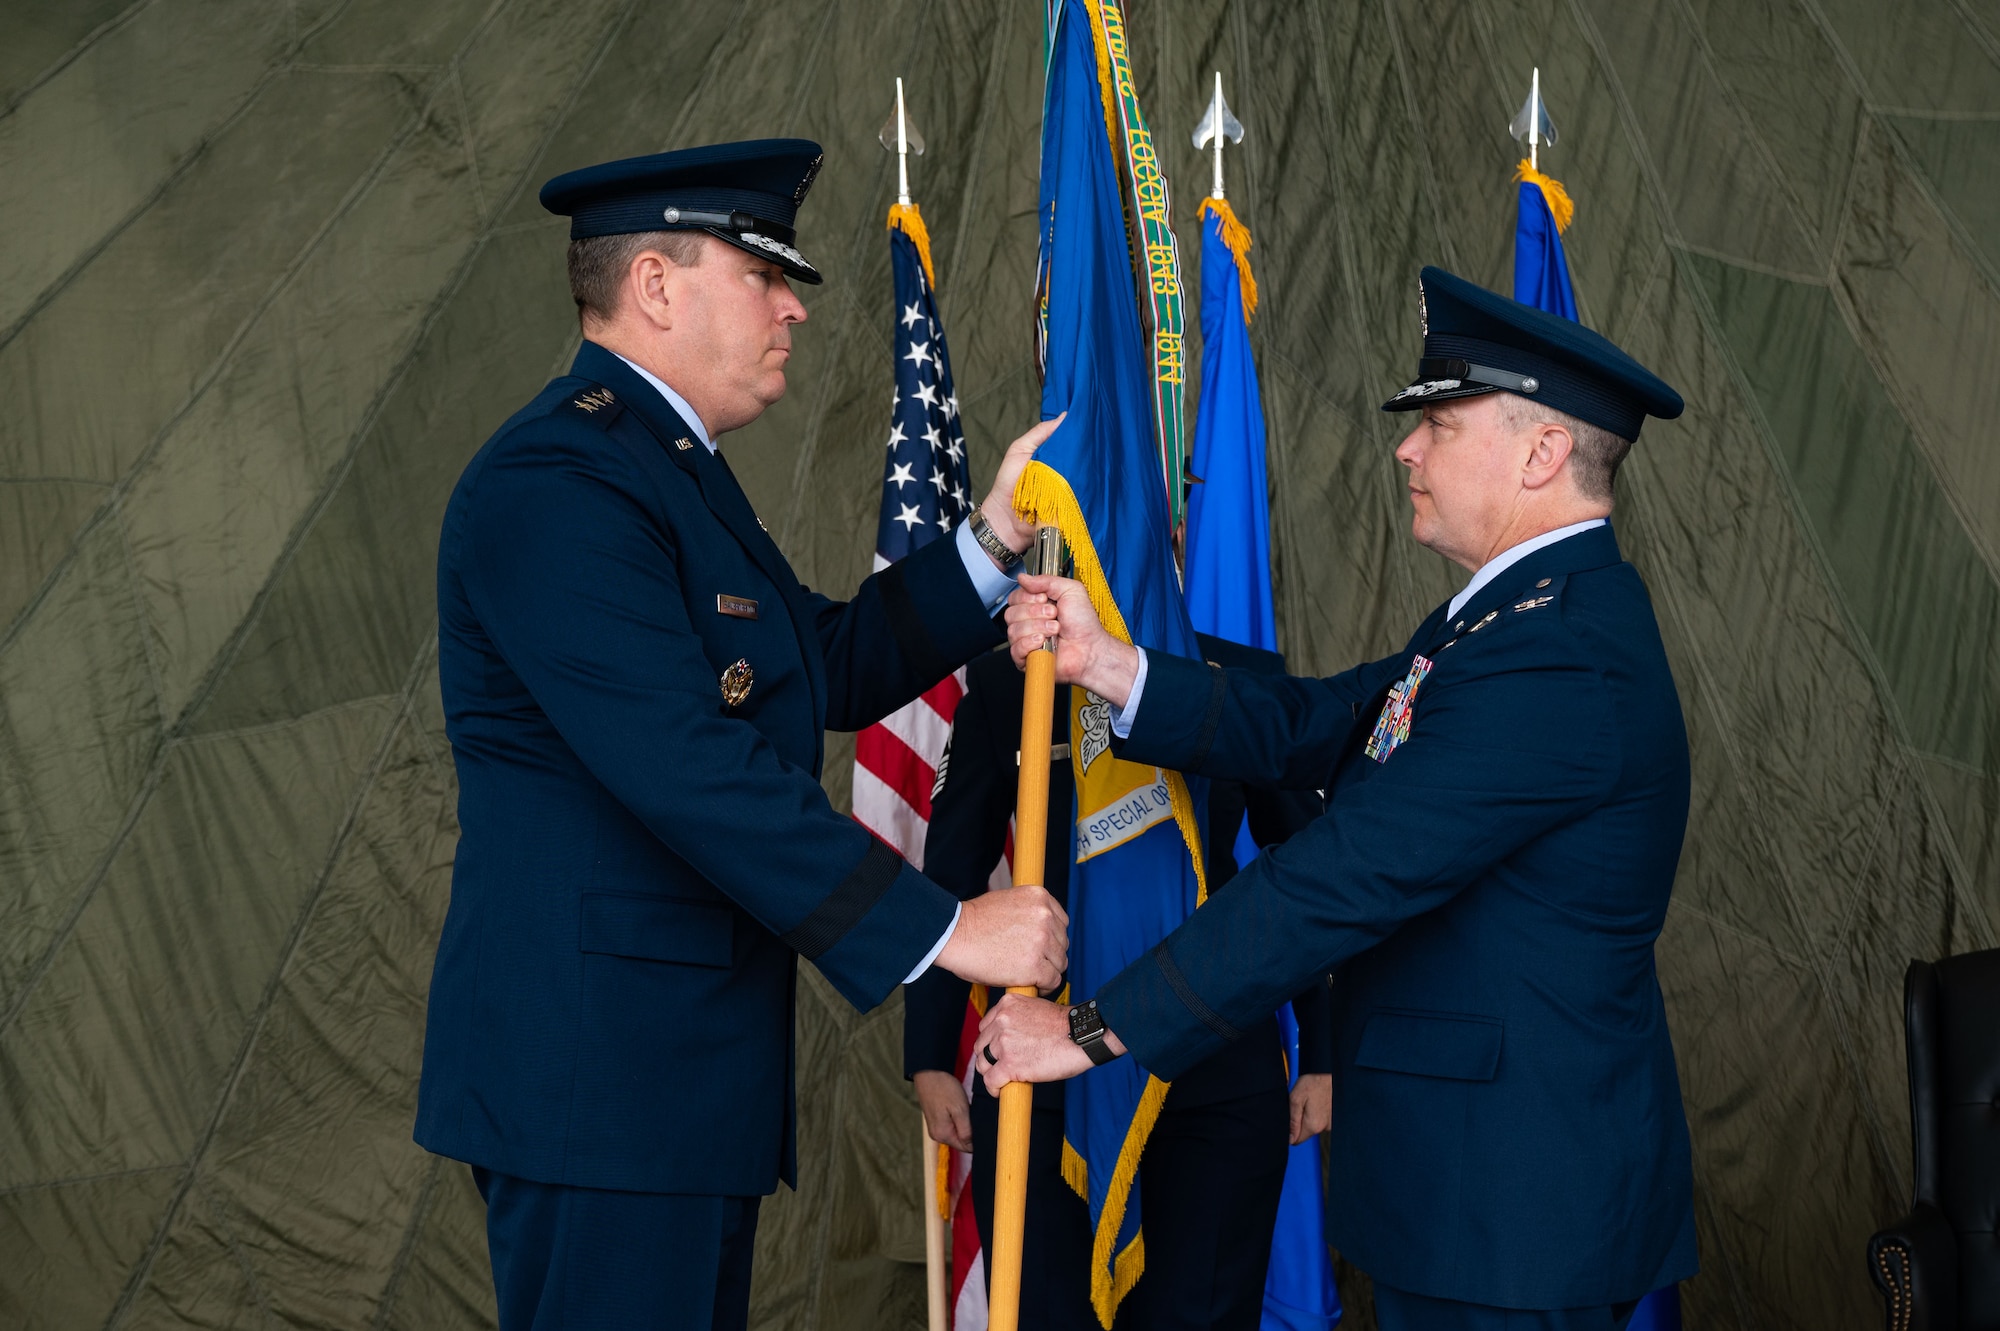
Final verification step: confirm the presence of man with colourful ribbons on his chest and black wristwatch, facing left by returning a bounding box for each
[982,268,1696,1331]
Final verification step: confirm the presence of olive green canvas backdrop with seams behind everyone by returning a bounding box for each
[0,0,2000,1331]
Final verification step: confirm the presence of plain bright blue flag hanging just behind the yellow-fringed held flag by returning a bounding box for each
[1188,198,1340,1331]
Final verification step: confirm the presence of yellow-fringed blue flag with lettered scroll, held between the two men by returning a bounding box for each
[1014,0,1204,1327]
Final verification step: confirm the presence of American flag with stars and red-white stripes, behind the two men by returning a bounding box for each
[854,216,972,867]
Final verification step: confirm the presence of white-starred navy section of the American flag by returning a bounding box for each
[876,230,972,566]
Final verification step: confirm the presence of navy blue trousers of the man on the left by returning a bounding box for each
[472,1165,762,1331]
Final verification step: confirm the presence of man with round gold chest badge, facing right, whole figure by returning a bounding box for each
[416,140,1068,1331]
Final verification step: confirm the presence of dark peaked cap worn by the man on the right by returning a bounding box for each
[1382,268,1682,440]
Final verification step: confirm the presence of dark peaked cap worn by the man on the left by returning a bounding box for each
[542,138,826,284]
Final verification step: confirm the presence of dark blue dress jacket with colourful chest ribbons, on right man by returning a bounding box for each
[1096,526,1696,1309]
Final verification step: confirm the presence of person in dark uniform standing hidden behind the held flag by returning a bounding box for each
[902,634,1334,1331]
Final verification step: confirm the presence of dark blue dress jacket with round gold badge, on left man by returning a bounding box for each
[416,342,1002,1197]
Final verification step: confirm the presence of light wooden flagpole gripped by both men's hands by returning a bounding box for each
[986,528,1062,1331]
